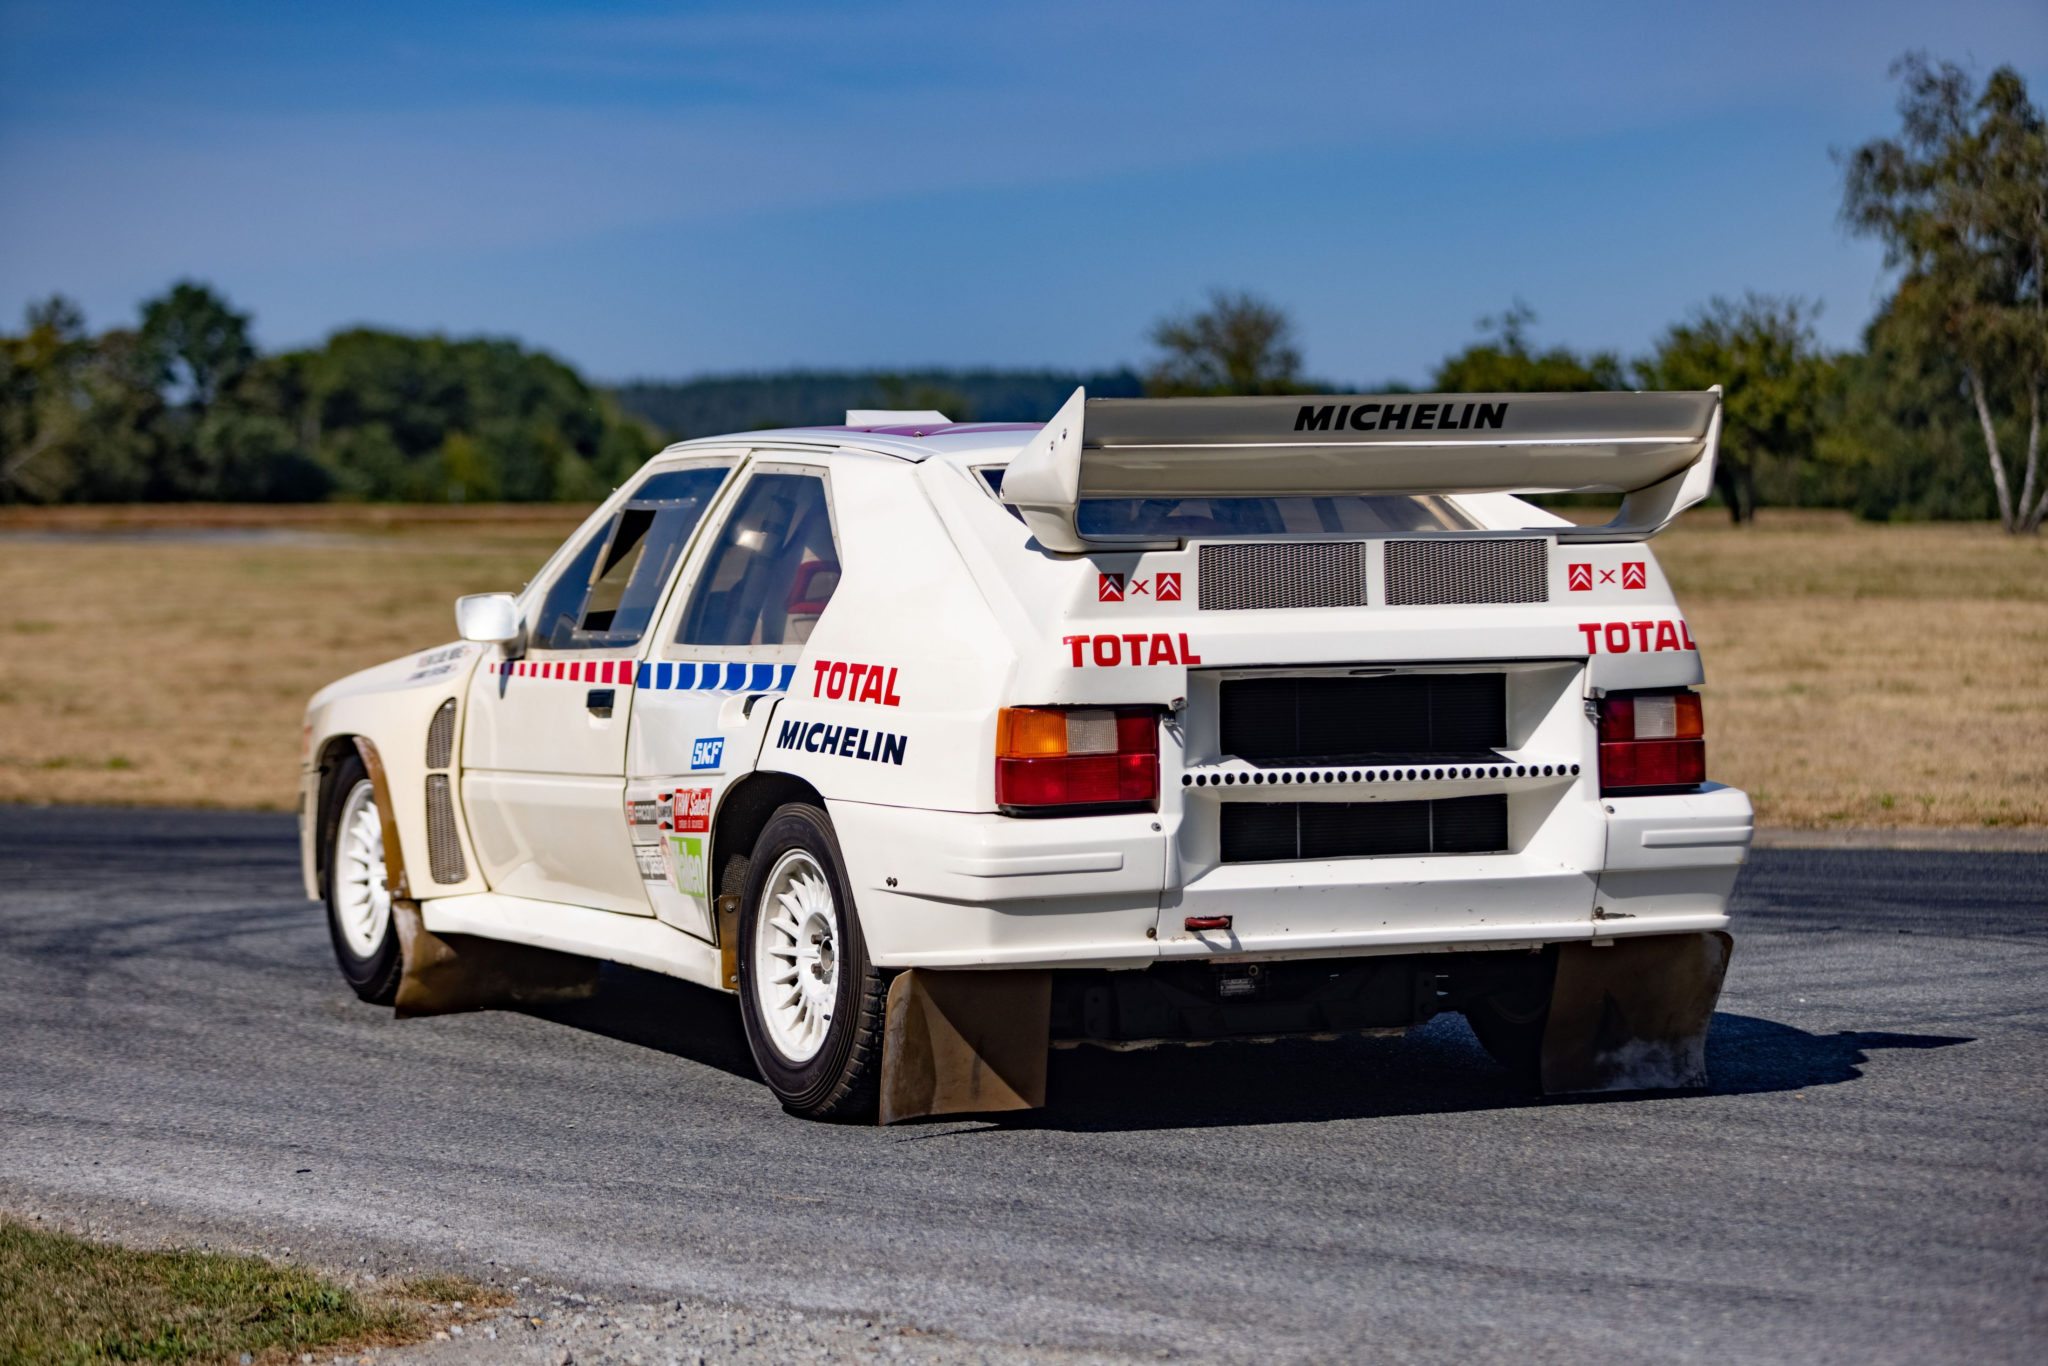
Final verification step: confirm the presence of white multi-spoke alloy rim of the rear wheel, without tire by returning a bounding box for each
[754,850,840,1063]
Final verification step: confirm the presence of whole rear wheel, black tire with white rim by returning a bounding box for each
[737,803,889,1120]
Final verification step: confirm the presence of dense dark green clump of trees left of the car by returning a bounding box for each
[0,281,659,502]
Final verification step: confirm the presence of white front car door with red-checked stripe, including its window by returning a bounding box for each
[463,453,737,915]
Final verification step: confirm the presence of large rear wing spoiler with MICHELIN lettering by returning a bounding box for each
[1001,385,1720,555]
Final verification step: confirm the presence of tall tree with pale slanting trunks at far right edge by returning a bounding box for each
[1841,53,2048,532]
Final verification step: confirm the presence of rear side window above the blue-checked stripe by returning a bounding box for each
[676,473,840,645]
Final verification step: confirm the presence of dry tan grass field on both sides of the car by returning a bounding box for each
[0,506,2048,827]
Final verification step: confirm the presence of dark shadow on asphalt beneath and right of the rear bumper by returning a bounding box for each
[995,1014,1972,1130]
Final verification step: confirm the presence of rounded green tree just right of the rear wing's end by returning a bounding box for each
[1636,293,1835,524]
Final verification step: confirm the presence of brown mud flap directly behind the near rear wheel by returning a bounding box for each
[881,969,1053,1124]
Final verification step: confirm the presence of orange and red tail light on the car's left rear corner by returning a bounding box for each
[995,707,1159,815]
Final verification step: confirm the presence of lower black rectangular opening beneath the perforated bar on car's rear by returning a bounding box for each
[1221,793,1507,864]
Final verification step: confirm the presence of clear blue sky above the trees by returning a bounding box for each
[0,0,2048,383]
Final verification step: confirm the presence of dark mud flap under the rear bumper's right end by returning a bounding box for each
[1542,930,1735,1096]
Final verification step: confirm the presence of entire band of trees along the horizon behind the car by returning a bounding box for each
[0,55,2048,530]
